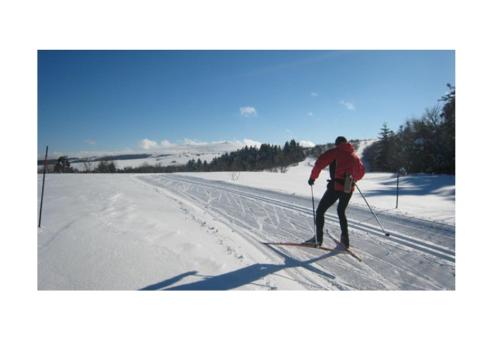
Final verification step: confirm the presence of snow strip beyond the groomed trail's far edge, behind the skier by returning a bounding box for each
[180,159,455,224]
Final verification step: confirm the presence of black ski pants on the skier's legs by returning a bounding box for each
[316,187,352,242]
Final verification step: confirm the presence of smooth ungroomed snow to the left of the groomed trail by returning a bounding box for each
[38,174,301,290]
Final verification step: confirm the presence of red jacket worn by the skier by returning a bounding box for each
[310,143,365,192]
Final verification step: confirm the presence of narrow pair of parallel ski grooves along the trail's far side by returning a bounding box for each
[158,175,455,263]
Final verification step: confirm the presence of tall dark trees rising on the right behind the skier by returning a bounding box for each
[363,84,455,174]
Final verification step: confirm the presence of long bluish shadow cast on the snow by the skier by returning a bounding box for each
[141,246,339,290]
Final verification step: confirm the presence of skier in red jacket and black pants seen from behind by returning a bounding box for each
[305,136,365,248]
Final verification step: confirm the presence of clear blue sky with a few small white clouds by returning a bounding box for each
[38,50,455,155]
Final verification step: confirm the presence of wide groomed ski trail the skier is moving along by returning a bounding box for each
[136,174,455,290]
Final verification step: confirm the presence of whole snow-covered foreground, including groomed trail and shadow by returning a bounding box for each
[38,160,455,290]
